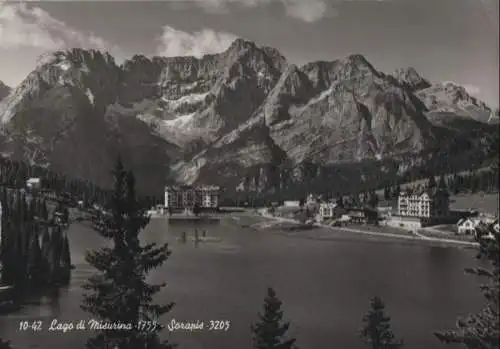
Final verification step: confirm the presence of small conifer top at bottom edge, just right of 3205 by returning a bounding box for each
[251,288,295,349]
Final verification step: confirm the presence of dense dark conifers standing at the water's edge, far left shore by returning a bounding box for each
[0,187,71,290]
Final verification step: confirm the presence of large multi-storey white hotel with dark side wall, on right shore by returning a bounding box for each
[397,189,450,218]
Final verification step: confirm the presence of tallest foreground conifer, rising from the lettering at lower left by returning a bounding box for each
[82,160,173,349]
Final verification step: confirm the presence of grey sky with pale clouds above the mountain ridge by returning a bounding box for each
[0,0,499,107]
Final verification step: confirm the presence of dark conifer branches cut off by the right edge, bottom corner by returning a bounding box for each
[435,225,500,349]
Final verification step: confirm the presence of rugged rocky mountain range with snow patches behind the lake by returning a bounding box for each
[0,39,498,193]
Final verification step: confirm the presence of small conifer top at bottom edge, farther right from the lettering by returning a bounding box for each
[360,297,403,349]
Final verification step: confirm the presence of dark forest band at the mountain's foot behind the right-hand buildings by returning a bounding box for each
[221,126,499,206]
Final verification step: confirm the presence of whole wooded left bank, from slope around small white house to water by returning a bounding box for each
[0,157,114,294]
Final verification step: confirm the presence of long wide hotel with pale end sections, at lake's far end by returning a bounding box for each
[165,185,219,209]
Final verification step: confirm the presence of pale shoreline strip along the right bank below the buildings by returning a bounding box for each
[251,215,479,248]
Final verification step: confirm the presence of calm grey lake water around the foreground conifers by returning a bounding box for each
[0,217,482,349]
